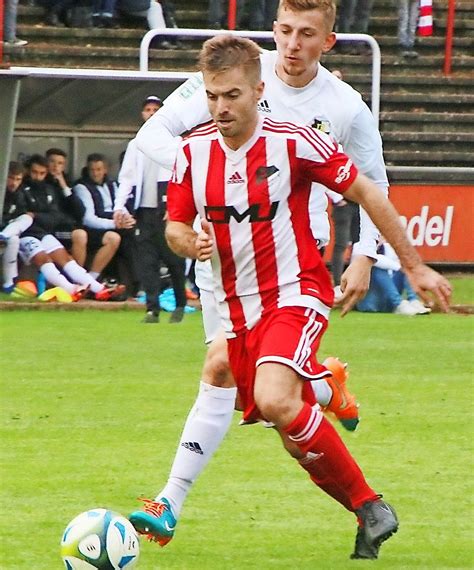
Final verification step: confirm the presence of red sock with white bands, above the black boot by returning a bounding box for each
[284,403,378,510]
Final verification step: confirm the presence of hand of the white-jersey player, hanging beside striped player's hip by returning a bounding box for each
[334,255,374,317]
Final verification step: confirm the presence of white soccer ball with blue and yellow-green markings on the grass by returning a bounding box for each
[61,509,140,570]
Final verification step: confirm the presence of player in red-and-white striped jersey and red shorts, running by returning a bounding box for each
[131,36,450,558]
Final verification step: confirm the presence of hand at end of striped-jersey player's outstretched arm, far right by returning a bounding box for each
[403,263,453,313]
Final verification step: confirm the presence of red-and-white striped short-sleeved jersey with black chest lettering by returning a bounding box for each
[168,118,357,336]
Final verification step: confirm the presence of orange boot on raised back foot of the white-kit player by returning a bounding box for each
[323,356,359,431]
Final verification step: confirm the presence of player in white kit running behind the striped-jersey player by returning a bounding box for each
[127,0,387,556]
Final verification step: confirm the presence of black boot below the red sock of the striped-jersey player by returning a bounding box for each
[356,499,398,551]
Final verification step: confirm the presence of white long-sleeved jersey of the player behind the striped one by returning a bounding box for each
[137,51,388,290]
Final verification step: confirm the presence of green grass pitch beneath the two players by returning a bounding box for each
[0,311,474,570]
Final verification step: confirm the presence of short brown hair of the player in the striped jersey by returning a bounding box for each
[199,34,261,84]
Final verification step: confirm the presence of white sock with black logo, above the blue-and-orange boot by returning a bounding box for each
[156,382,237,517]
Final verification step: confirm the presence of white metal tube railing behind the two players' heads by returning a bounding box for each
[140,28,382,127]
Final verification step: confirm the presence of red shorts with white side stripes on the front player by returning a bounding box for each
[227,307,329,420]
